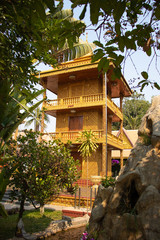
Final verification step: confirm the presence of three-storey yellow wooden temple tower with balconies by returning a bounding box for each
[40,55,132,179]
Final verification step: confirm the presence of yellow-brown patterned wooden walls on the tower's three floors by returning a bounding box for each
[56,69,103,179]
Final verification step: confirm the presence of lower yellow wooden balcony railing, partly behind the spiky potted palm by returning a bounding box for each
[43,130,123,149]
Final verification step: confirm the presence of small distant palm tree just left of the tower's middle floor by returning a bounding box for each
[25,108,49,132]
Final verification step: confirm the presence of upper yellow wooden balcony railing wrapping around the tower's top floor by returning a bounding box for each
[44,93,123,120]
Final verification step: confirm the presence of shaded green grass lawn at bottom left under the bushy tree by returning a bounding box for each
[0,209,62,240]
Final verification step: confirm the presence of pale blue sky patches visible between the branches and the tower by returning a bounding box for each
[22,0,160,132]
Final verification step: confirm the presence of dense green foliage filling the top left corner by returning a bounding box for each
[0,0,85,89]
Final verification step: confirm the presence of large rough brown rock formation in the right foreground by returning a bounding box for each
[89,96,160,240]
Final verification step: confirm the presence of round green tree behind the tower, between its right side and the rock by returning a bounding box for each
[123,93,150,130]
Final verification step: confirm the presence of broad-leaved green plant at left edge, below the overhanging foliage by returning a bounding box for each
[0,88,43,216]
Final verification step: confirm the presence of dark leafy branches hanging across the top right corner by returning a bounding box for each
[71,0,160,90]
